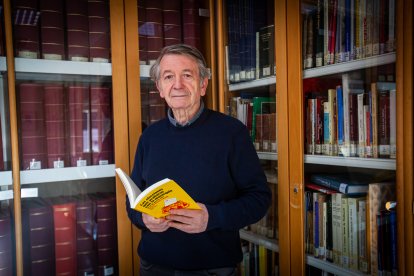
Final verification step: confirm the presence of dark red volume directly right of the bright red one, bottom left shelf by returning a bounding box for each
[75,195,97,275]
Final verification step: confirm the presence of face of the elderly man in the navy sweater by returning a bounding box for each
[157,54,208,114]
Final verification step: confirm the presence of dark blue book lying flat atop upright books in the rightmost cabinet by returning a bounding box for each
[310,174,372,195]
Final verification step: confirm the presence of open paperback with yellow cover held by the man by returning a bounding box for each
[115,168,201,218]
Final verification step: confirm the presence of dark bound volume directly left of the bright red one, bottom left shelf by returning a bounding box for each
[22,198,55,275]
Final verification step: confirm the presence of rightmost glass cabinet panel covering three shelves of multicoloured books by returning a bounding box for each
[302,0,398,275]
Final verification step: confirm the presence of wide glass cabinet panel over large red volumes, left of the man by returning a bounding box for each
[12,0,118,275]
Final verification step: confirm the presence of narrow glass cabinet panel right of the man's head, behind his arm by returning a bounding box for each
[224,0,279,275]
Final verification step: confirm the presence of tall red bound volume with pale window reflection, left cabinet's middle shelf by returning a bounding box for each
[68,85,91,167]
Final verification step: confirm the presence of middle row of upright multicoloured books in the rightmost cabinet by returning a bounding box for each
[305,74,396,159]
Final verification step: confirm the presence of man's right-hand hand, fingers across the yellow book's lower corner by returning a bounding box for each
[166,202,208,233]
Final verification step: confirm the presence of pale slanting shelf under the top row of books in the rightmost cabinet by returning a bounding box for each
[303,53,396,79]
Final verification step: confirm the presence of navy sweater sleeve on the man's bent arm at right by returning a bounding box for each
[207,127,271,230]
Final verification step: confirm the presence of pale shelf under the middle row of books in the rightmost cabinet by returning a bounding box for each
[305,154,397,171]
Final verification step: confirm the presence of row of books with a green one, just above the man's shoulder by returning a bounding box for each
[228,95,277,153]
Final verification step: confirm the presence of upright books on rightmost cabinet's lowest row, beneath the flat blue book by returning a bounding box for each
[305,178,397,275]
